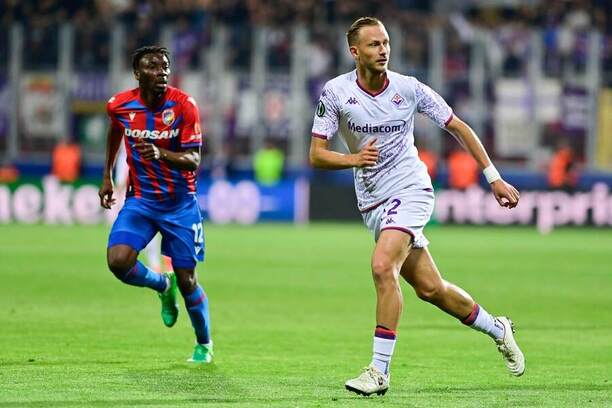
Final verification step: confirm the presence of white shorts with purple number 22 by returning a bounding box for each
[361,189,434,248]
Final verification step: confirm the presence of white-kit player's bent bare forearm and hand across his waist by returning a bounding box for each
[310,136,378,170]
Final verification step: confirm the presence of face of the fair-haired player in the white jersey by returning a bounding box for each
[350,24,391,73]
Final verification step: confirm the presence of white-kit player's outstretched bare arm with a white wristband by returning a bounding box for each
[446,115,520,208]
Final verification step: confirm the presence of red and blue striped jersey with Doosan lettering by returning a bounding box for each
[106,86,202,206]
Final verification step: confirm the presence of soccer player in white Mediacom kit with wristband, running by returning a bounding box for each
[310,17,525,395]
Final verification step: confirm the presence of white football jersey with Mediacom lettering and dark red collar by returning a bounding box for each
[312,70,453,211]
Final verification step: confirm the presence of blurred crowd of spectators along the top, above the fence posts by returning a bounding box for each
[0,0,612,79]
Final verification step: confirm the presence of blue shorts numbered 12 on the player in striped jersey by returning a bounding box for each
[108,196,204,269]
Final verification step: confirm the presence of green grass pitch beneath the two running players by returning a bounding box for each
[0,224,612,408]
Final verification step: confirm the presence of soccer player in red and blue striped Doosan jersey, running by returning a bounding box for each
[99,46,213,363]
